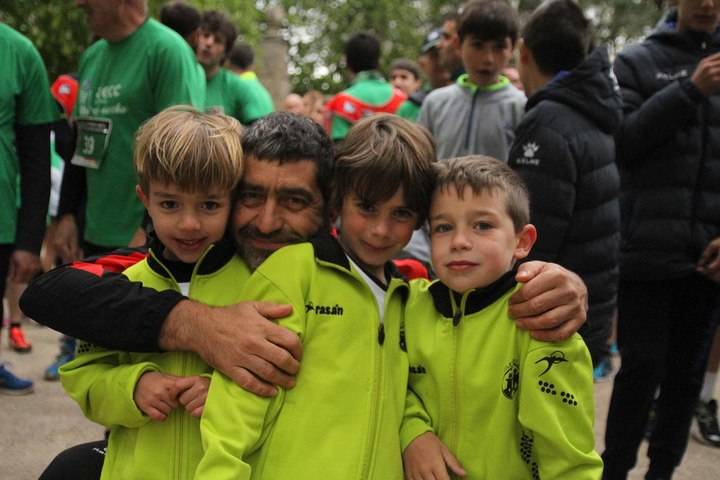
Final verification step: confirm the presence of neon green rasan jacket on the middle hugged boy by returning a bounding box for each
[196,237,408,480]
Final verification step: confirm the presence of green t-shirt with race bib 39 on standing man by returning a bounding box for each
[74,19,203,247]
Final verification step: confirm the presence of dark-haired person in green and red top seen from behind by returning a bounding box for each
[325,33,407,141]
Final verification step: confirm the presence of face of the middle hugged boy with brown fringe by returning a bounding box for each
[340,187,418,280]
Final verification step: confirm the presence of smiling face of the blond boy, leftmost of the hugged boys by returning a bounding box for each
[137,182,230,263]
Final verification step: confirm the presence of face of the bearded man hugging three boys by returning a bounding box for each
[233,157,325,270]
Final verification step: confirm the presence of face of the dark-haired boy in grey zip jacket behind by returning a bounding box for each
[460,35,513,87]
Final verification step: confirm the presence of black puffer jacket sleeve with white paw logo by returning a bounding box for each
[509,122,577,262]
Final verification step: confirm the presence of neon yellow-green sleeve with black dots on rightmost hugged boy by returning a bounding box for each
[518,334,603,480]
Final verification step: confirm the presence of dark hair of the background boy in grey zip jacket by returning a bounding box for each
[458,0,519,45]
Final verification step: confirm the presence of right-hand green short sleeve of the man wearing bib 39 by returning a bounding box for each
[150,40,205,112]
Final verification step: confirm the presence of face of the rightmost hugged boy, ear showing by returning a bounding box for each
[430,187,536,293]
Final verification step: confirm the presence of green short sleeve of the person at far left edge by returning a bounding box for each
[15,39,59,125]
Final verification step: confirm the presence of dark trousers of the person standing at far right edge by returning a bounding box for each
[603,274,718,480]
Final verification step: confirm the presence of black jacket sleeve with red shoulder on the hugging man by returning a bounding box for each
[20,250,185,352]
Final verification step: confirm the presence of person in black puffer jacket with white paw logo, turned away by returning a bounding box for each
[509,0,622,380]
